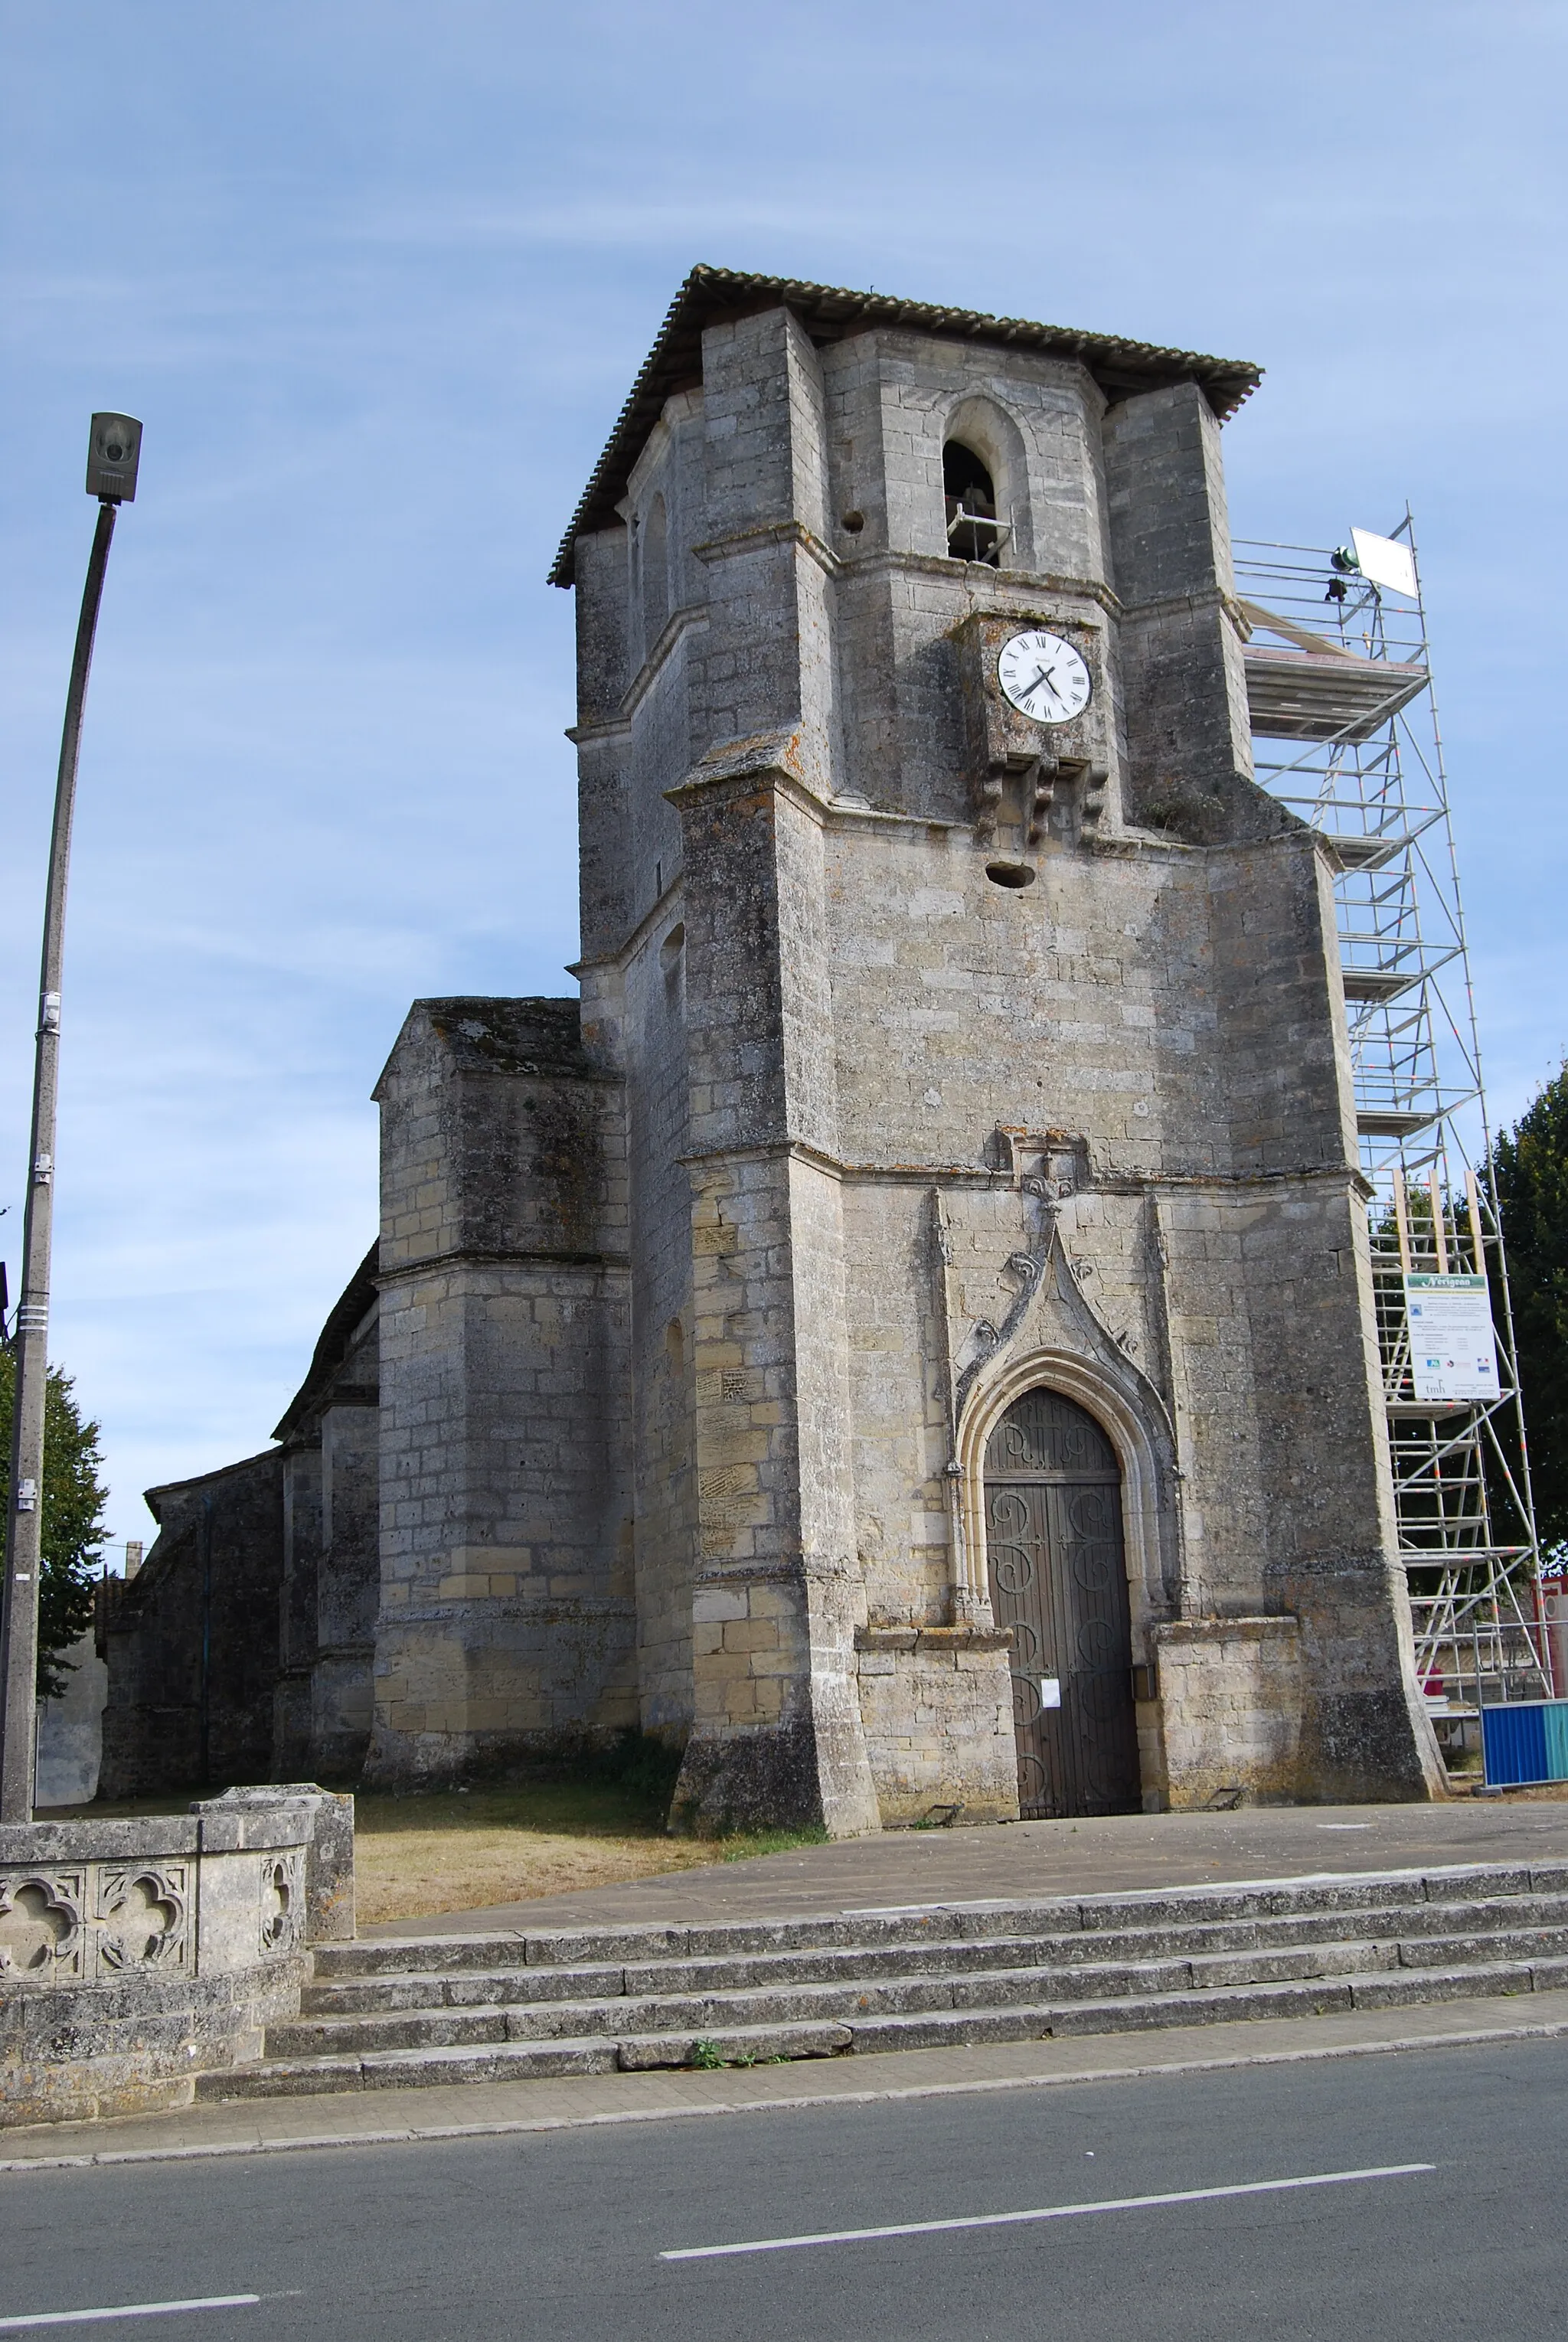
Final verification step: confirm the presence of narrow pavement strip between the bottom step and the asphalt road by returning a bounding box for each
[0,1991,1568,2180]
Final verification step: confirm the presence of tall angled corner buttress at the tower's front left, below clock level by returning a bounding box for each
[661,730,877,1829]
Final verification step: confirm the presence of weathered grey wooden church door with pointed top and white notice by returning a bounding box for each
[985,1389,1142,1820]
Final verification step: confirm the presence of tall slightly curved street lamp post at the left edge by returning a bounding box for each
[0,414,141,1822]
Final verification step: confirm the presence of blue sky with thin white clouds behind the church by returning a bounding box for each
[0,0,1568,1539]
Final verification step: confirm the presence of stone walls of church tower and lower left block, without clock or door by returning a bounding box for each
[97,269,1442,1834]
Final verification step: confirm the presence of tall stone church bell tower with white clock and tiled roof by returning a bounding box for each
[556,269,1437,1831]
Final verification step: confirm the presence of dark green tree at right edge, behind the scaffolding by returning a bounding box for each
[1491,1063,1568,1550]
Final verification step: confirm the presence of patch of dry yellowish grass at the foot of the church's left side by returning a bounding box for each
[354,1782,825,1925]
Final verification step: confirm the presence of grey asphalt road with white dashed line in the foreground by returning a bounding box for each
[0,2042,1568,2342]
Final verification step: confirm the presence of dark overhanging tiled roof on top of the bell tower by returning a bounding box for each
[550,267,1261,586]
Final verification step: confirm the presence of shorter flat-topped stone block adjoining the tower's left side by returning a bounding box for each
[366,1000,638,1782]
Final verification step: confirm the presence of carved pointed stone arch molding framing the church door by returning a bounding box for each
[954,1230,1181,1646]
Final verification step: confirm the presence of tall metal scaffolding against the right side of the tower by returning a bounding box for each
[1235,511,1568,1763]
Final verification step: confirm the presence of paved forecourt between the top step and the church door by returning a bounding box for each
[361,1798,1568,1939]
